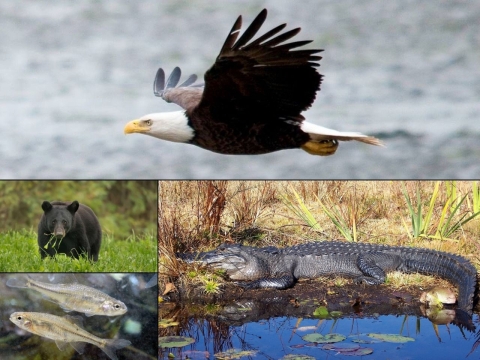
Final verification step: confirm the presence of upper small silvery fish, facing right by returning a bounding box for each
[7,276,127,316]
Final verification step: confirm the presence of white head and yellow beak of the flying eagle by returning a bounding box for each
[123,111,195,143]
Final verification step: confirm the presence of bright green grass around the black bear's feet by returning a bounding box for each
[0,231,157,272]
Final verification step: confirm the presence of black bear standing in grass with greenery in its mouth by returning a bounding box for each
[38,200,102,261]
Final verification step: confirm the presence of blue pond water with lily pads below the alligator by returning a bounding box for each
[159,301,480,360]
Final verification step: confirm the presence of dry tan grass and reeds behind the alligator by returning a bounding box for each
[159,181,480,291]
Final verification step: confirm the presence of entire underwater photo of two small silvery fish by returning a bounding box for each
[0,273,157,360]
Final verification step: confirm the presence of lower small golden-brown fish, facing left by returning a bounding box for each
[10,312,131,360]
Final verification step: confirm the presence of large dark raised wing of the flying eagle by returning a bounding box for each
[192,9,322,122]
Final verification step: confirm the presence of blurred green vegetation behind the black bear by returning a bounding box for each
[0,180,157,240]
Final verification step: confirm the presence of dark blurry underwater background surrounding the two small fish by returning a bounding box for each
[0,273,157,360]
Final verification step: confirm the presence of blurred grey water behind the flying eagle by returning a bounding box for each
[0,0,480,179]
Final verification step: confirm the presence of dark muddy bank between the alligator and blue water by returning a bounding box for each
[159,279,480,331]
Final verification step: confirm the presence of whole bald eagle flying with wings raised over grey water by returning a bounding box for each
[124,9,381,155]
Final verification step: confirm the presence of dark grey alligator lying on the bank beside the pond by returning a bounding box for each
[180,241,477,315]
